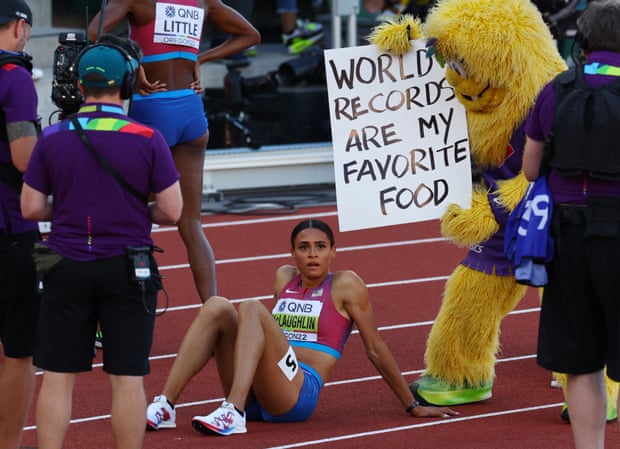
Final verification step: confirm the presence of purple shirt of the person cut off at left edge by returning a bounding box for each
[0,59,38,234]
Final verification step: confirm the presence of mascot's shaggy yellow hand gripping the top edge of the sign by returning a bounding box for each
[367,14,422,56]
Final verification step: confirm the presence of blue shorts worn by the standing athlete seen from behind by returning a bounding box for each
[129,89,209,147]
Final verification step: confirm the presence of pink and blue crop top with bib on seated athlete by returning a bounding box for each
[271,274,353,359]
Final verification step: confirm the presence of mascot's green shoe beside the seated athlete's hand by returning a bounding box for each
[409,376,493,406]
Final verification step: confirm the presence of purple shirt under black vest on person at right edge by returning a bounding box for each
[525,51,620,205]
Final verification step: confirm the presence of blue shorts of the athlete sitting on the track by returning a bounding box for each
[245,362,323,422]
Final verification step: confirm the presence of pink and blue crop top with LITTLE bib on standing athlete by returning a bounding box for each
[129,0,205,62]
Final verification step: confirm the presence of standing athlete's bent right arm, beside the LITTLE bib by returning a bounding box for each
[198,0,260,64]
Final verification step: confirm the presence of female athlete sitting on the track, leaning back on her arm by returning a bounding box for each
[147,220,457,435]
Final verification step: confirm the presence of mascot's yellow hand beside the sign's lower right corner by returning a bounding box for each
[441,187,499,248]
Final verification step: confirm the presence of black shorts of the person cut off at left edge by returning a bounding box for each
[0,232,40,358]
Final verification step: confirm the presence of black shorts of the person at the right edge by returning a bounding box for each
[538,206,620,381]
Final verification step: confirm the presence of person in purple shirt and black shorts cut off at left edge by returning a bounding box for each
[0,0,39,449]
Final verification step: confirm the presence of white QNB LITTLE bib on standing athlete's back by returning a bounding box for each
[153,2,205,48]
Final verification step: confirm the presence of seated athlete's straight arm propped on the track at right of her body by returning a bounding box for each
[332,271,457,417]
